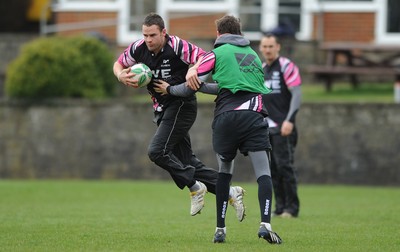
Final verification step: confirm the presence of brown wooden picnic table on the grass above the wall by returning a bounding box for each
[308,42,400,91]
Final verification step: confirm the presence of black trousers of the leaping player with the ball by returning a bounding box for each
[148,100,218,193]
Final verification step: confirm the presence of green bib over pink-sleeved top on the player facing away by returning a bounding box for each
[197,34,270,116]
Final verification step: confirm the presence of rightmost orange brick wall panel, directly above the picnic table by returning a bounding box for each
[313,12,375,42]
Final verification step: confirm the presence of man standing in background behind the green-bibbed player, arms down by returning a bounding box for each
[259,33,301,218]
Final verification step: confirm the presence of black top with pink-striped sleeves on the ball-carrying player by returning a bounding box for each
[118,34,205,111]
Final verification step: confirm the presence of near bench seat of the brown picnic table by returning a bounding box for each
[307,65,400,91]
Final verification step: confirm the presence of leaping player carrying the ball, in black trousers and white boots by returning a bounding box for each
[113,13,245,221]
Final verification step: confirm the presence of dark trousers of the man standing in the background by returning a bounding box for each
[270,129,300,216]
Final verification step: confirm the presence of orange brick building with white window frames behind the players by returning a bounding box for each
[50,0,400,46]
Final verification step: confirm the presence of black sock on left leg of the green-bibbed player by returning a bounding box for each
[216,173,232,228]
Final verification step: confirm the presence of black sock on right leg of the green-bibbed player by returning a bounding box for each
[257,175,272,223]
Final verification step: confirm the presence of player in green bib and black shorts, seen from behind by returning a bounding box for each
[156,16,282,244]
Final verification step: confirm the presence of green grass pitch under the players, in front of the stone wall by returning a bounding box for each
[0,180,400,252]
